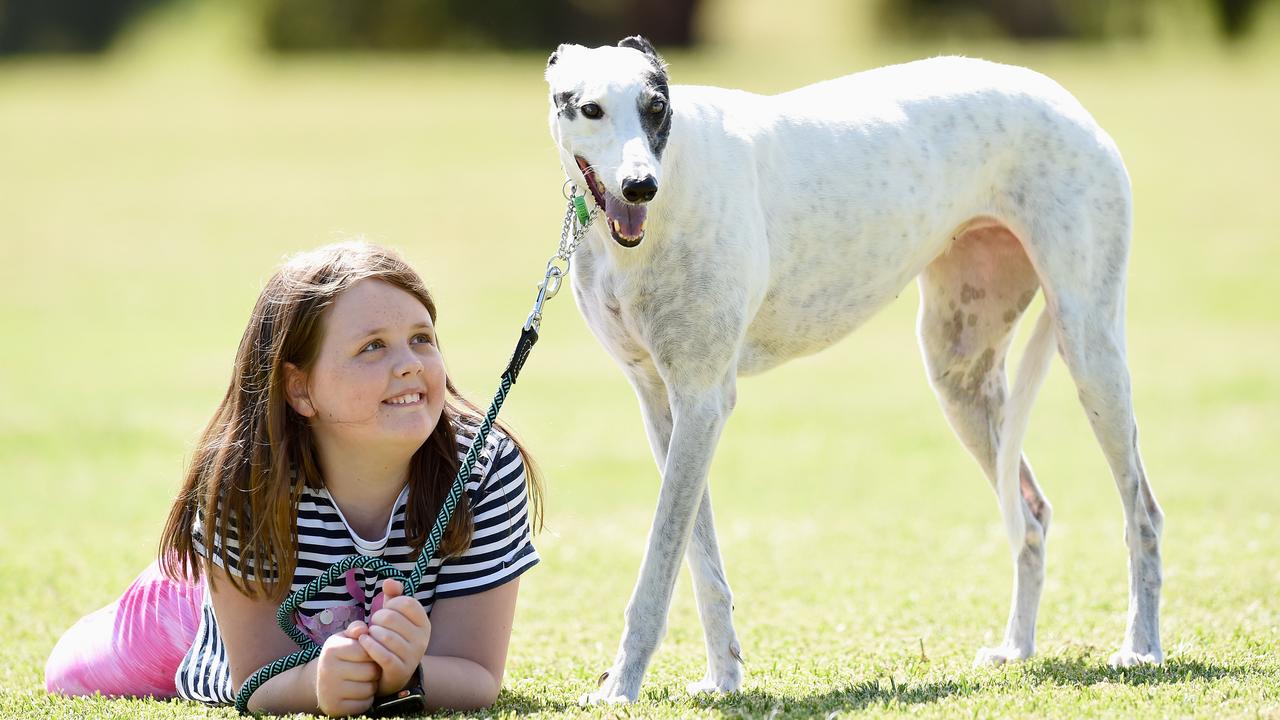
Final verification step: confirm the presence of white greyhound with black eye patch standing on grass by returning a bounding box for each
[545,37,1164,703]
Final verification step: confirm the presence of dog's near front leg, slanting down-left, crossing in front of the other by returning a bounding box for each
[582,375,733,703]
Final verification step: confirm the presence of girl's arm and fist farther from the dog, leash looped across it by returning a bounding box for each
[207,566,379,715]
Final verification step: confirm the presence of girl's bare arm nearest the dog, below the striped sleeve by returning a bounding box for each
[422,578,520,710]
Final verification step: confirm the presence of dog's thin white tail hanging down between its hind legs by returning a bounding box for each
[996,306,1057,548]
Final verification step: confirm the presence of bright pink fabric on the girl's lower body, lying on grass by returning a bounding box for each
[45,562,205,698]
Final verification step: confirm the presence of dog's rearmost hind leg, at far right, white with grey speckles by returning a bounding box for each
[1013,189,1165,666]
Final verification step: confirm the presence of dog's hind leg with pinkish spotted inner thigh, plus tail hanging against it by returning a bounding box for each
[918,224,1052,664]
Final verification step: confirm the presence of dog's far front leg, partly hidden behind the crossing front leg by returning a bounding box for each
[630,373,742,694]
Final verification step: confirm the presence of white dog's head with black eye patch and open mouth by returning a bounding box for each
[547,36,671,247]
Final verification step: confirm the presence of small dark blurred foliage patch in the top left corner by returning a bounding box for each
[0,0,161,55]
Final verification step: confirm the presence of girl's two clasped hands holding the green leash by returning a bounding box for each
[316,580,431,716]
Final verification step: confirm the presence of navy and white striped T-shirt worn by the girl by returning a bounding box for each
[174,425,539,705]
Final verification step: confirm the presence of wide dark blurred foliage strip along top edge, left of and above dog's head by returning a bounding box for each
[256,0,699,51]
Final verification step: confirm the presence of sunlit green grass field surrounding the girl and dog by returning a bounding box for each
[0,12,1280,717]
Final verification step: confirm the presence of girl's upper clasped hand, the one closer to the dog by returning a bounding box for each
[357,580,431,696]
